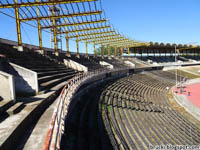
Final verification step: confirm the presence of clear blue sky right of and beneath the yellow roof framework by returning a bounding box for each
[0,0,200,52]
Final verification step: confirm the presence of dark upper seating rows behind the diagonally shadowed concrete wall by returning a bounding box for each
[0,44,77,93]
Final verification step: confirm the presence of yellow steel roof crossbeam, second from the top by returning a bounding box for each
[20,11,102,21]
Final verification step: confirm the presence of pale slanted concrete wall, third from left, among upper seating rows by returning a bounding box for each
[64,59,88,72]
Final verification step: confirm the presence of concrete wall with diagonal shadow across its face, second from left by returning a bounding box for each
[7,63,39,95]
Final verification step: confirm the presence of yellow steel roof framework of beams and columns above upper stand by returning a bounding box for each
[0,0,145,56]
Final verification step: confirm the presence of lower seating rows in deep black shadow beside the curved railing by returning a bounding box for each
[61,82,113,150]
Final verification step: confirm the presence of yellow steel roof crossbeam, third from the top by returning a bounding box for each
[42,19,107,29]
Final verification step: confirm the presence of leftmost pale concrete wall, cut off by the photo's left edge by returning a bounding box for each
[0,71,16,101]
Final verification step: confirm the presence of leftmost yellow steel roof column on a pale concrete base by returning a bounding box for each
[15,0,23,51]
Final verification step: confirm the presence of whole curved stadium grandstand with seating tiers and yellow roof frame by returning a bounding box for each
[0,0,200,150]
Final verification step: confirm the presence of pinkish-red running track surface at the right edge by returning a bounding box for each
[174,83,200,108]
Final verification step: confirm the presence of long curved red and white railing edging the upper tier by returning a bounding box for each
[43,68,130,150]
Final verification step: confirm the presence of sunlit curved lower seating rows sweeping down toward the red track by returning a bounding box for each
[100,73,200,149]
